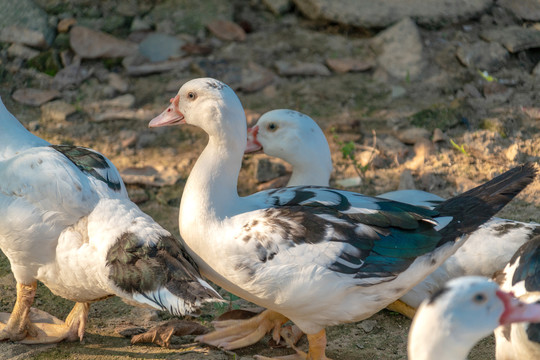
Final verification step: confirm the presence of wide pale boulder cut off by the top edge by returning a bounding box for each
[293,0,493,28]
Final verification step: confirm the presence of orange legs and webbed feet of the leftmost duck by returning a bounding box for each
[0,281,90,344]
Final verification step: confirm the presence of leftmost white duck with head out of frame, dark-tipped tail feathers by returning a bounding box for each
[0,99,222,344]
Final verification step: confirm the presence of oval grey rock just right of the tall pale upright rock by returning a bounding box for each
[456,41,510,71]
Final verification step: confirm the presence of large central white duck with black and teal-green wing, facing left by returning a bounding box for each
[149,78,536,359]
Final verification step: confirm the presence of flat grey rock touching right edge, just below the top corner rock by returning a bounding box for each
[480,26,540,53]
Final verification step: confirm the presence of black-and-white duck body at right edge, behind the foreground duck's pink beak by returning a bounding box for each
[494,235,540,360]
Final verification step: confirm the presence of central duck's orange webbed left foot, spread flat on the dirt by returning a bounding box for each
[195,310,289,350]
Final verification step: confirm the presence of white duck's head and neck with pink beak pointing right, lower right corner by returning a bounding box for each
[407,276,540,360]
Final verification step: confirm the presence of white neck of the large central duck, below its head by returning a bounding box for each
[180,136,245,232]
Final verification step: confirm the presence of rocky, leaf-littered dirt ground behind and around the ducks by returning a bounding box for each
[0,0,540,359]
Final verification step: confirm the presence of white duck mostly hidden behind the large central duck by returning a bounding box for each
[246,109,540,317]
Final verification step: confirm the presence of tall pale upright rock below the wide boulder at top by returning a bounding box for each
[371,18,425,80]
